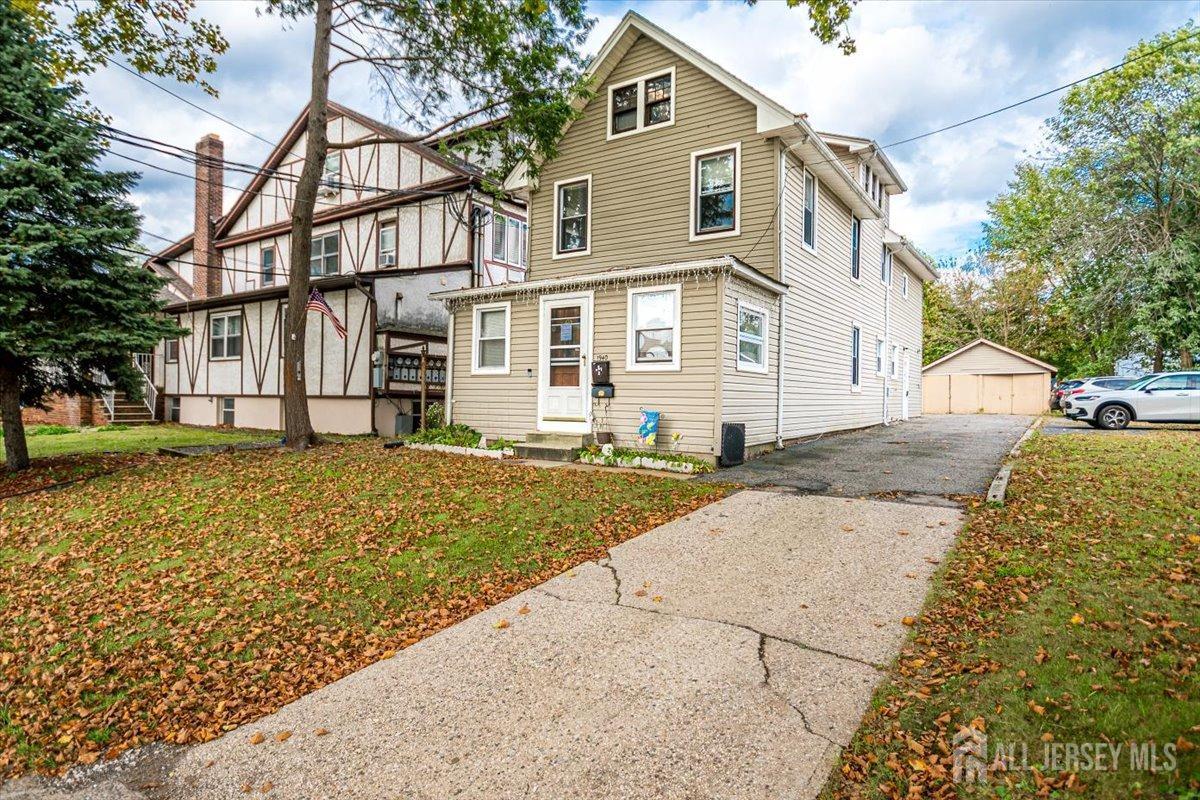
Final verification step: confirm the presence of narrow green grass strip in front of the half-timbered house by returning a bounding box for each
[0,422,270,458]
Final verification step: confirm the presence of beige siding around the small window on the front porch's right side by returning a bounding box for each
[721,277,779,446]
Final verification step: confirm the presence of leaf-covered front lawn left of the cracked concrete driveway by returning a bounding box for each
[0,441,727,774]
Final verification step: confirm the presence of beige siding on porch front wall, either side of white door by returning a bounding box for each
[452,279,721,456]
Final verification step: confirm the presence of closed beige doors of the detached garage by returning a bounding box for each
[922,373,1050,414]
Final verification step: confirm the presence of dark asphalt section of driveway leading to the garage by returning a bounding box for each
[704,414,1033,500]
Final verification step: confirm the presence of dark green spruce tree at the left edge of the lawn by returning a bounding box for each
[0,2,180,469]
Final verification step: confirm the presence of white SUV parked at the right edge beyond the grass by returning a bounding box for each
[1062,372,1200,431]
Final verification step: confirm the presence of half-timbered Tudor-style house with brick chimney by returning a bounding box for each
[149,103,527,435]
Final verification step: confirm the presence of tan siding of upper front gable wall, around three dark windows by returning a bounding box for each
[529,37,776,279]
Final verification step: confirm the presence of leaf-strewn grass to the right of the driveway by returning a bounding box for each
[826,431,1200,800]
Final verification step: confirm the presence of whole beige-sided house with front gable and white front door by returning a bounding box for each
[434,12,936,458]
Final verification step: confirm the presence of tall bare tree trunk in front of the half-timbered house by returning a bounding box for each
[283,0,334,450]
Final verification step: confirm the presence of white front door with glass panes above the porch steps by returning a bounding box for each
[538,294,592,433]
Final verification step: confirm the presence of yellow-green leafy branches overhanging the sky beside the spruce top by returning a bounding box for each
[14,0,229,96]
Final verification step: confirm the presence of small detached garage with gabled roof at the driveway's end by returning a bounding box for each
[922,339,1057,414]
